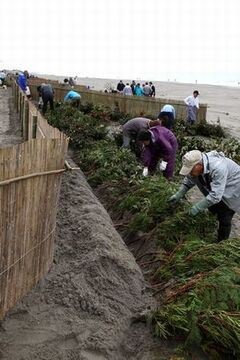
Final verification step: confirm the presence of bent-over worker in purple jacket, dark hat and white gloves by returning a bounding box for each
[138,125,178,179]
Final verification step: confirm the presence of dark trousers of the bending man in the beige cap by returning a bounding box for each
[209,201,235,241]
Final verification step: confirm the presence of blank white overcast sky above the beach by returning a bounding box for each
[0,0,240,80]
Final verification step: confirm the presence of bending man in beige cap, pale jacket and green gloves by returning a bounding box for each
[169,150,240,241]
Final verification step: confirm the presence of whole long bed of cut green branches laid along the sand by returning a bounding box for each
[48,104,240,359]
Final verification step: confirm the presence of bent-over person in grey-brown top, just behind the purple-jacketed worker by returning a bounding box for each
[122,117,160,148]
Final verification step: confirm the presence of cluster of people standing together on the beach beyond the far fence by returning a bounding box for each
[117,80,156,97]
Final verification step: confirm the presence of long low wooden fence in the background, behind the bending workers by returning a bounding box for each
[29,79,207,122]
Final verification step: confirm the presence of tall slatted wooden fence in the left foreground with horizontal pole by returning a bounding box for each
[0,84,68,319]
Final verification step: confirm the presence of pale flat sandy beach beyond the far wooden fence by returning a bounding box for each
[42,75,240,138]
